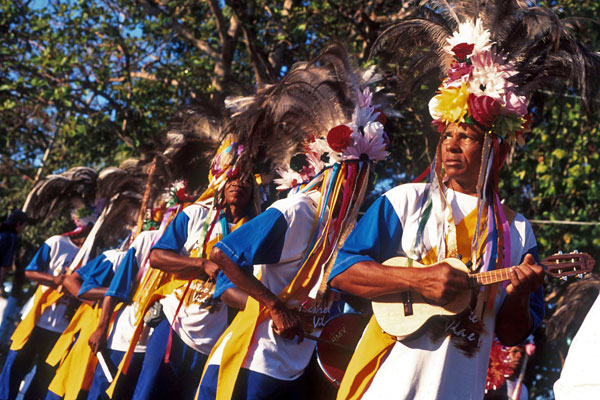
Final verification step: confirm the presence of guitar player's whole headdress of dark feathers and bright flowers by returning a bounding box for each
[374,0,600,140]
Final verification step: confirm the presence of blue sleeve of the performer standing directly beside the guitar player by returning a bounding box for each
[215,208,288,273]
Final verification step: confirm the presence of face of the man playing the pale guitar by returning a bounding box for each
[441,123,484,195]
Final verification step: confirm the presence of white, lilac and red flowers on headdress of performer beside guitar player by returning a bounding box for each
[273,88,389,191]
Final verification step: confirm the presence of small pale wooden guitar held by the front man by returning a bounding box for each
[372,252,595,340]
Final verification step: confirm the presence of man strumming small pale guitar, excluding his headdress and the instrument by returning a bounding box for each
[330,123,543,399]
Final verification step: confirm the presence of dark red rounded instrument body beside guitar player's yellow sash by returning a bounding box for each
[317,313,369,387]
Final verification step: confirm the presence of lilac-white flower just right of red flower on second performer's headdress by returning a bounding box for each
[341,121,389,161]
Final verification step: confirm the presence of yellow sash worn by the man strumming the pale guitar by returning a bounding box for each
[337,205,485,400]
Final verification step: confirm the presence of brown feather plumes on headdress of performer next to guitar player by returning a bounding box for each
[224,45,390,181]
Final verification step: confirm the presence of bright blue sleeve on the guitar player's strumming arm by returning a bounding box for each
[328,196,402,282]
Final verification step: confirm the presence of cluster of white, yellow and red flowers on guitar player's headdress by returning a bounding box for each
[429,20,531,145]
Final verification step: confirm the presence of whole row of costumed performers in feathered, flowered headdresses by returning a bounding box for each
[0,1,600,399]
